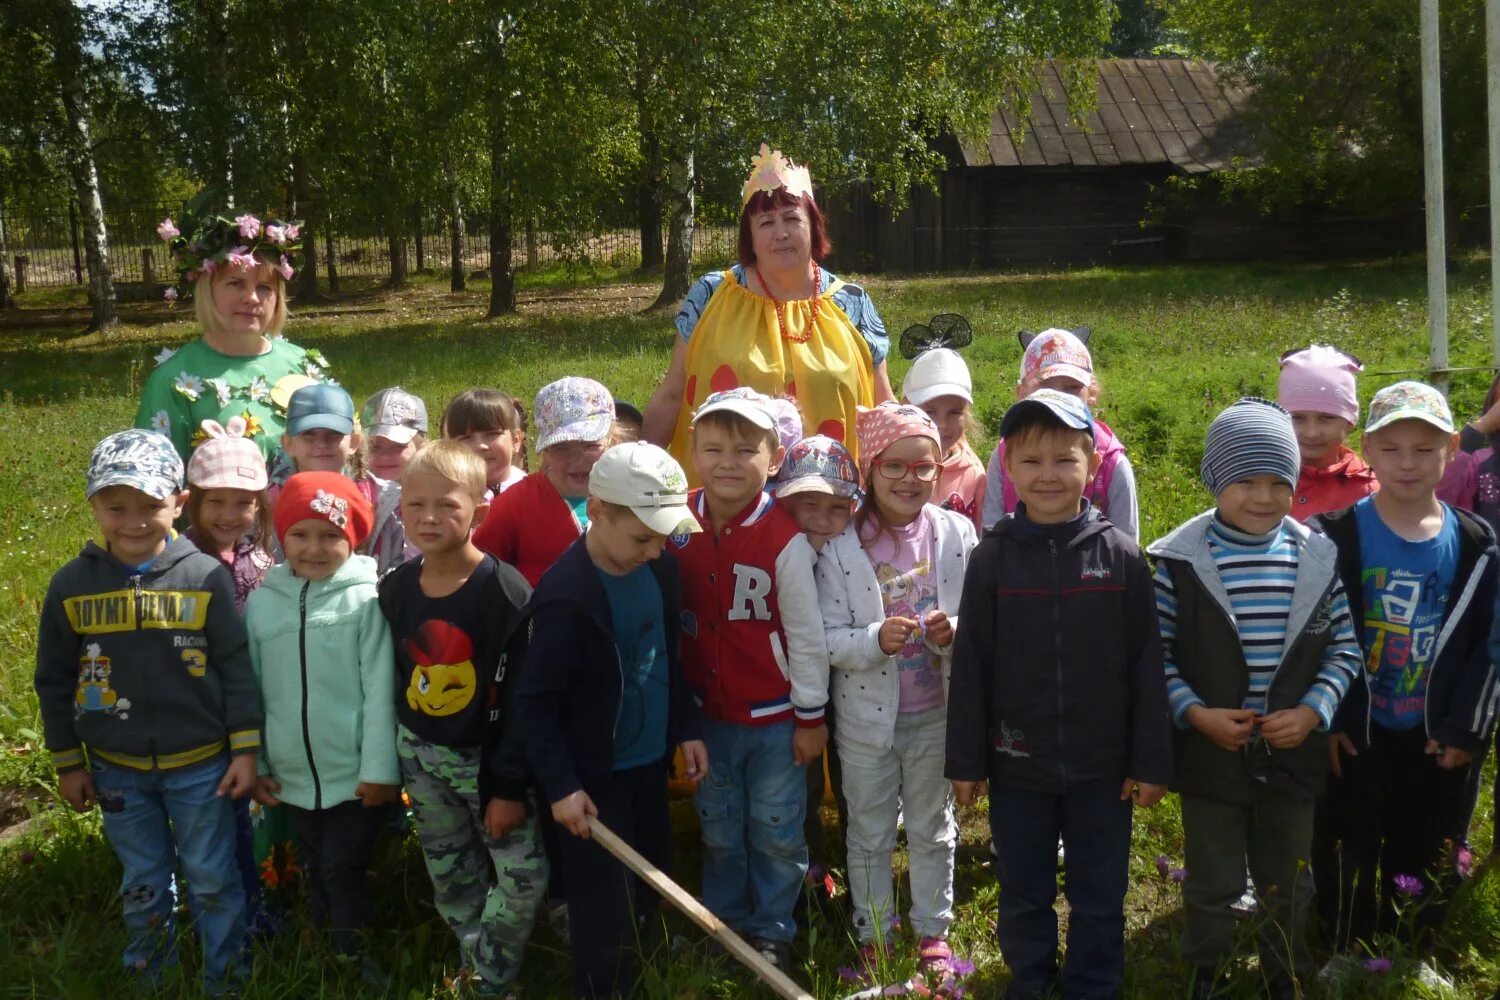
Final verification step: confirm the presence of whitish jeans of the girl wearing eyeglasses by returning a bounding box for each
[839,708,959,942]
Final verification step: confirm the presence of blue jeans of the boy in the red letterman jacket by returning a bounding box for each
[693,718,807,942]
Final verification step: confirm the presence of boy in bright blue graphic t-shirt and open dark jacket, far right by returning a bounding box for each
[1314,382,1497,946]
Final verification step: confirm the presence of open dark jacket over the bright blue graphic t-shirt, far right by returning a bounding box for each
[1308,507,1500,754]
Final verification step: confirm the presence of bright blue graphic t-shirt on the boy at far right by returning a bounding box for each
[1355,496,1458,730]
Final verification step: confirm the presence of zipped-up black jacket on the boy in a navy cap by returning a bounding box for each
[945,504,1172,793]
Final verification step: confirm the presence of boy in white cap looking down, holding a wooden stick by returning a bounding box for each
[515,442,708,997]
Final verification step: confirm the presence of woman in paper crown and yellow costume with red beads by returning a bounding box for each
[644,142,894,478]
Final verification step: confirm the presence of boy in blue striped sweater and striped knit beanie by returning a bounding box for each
[1149,399,1359,997]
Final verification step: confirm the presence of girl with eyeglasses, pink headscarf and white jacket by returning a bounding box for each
[818,402,977,993]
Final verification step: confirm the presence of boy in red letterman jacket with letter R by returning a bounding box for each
[672,388,828,970]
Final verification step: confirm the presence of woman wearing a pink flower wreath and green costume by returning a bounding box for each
[135,192,327,462]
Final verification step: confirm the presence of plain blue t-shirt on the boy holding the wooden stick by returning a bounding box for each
[599,567,668,771]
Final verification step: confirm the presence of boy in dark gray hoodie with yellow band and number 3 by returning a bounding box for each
[36,430,261,994]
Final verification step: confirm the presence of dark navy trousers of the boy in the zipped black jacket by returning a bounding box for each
[990,786,1131,1000]
